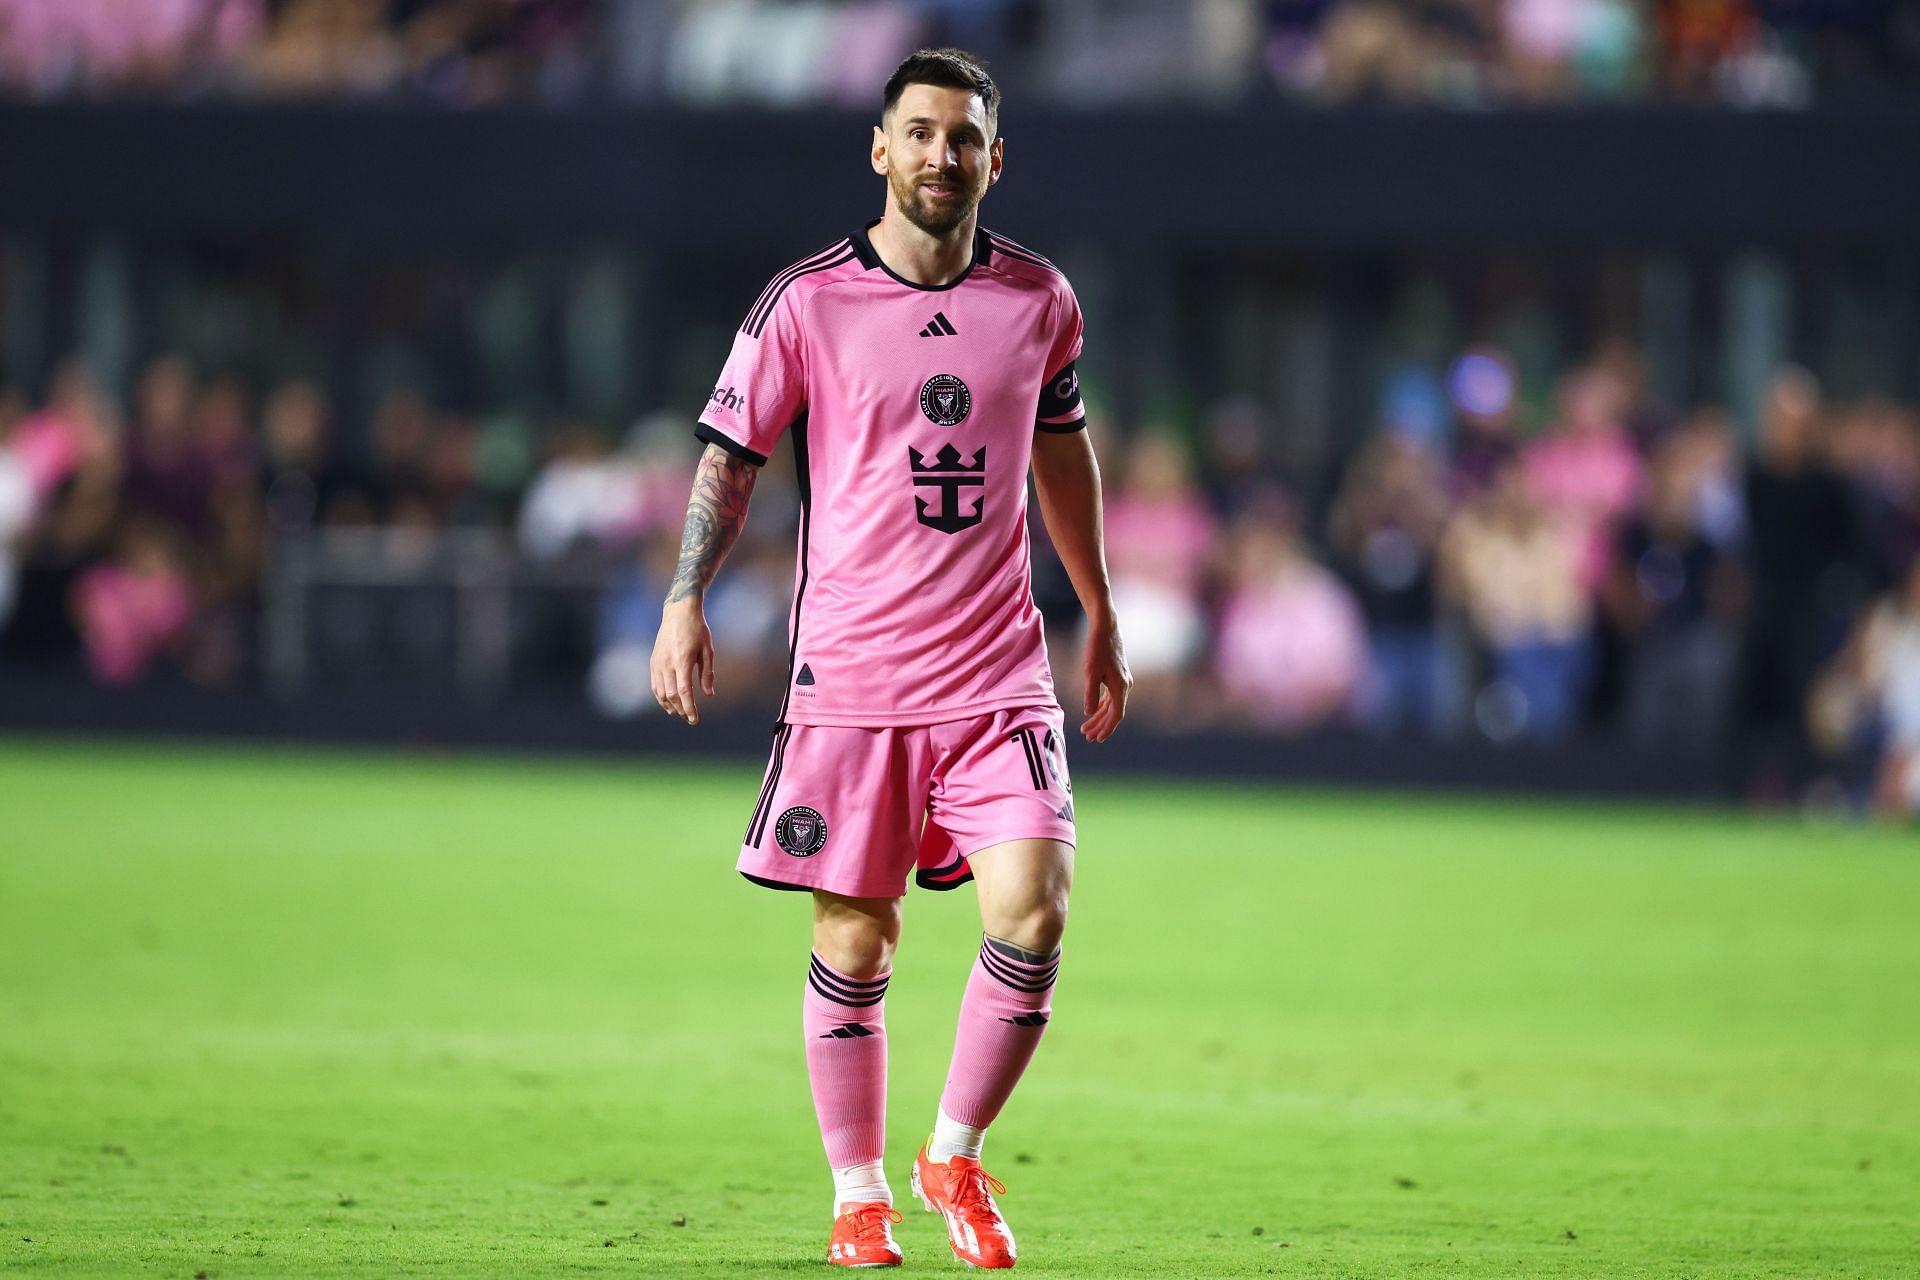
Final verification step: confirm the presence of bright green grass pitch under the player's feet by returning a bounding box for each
[0,741,1920,1280]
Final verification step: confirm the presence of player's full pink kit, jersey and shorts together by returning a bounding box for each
[697,222,1087,898]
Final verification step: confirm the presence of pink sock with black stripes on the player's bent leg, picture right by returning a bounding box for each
[941,938,1060,1128]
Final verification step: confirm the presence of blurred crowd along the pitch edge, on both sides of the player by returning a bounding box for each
[11,342,1920,812]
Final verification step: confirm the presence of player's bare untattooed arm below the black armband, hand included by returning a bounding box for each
[1033,430,1133,743]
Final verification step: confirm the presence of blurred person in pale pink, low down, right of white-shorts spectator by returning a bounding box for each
[1205,497,1367,733]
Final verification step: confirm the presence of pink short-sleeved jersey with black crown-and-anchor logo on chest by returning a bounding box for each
[697,230,1087,727]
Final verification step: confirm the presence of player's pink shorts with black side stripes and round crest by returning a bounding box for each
[739,706,1073,898]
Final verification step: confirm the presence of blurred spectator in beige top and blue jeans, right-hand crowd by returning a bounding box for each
[1440,462,1592,741]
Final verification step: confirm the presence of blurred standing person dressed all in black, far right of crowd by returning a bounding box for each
[1734,368,1855,802]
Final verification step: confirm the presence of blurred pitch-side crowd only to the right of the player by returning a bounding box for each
[1082,344,1920,808]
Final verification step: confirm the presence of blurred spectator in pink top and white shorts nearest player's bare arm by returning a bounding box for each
[1106,432,1217,720]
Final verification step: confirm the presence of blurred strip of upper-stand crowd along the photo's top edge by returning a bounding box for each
[0,0,1920,107]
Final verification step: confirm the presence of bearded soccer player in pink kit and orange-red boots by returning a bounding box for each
[653,50,1133,1267]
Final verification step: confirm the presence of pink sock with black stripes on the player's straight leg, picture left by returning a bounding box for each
[801,956,893,1169]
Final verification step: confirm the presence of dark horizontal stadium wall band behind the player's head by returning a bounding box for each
[0,104,1920,249]
